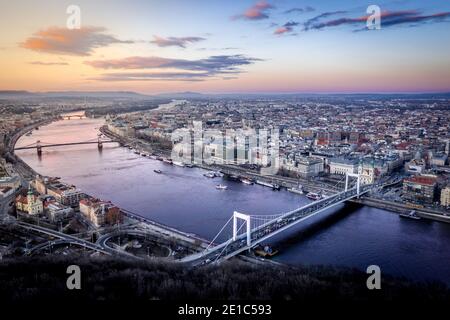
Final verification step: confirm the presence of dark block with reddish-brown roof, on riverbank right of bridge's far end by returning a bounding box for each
[403,175,437,204]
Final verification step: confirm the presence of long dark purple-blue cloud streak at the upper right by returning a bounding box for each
[304,10,450,31]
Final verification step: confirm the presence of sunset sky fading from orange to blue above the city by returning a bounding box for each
[0,0,450,94]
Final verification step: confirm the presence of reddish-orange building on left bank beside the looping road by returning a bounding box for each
[80,198,123,227]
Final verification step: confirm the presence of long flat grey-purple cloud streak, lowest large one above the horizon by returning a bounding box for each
[85,55,261,81]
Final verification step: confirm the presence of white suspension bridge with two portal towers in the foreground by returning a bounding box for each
[181,173,376,266]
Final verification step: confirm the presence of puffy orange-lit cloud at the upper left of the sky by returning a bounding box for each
[20,26,132,56]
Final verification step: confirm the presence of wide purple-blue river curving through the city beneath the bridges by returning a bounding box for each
[17,119,450,285]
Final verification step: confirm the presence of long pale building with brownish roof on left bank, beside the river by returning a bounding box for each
[34,176,84,207]
